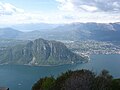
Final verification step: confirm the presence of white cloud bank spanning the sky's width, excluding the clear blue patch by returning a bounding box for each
[0,0,120,25]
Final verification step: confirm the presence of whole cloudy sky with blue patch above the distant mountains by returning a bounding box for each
[0,0,120,25]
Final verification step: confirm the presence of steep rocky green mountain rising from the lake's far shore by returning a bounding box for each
[0,39,85,65]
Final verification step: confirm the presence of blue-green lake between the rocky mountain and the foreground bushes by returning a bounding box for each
[0,55,120,90]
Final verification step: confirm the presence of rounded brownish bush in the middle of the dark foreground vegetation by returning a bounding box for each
[62,70,95,90]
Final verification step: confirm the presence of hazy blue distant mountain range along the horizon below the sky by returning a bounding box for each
[0,23,120,41]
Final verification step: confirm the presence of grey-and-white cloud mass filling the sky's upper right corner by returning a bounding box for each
[56,0,120,12]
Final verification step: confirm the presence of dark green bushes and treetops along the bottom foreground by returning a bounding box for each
[32,70,120,90]
